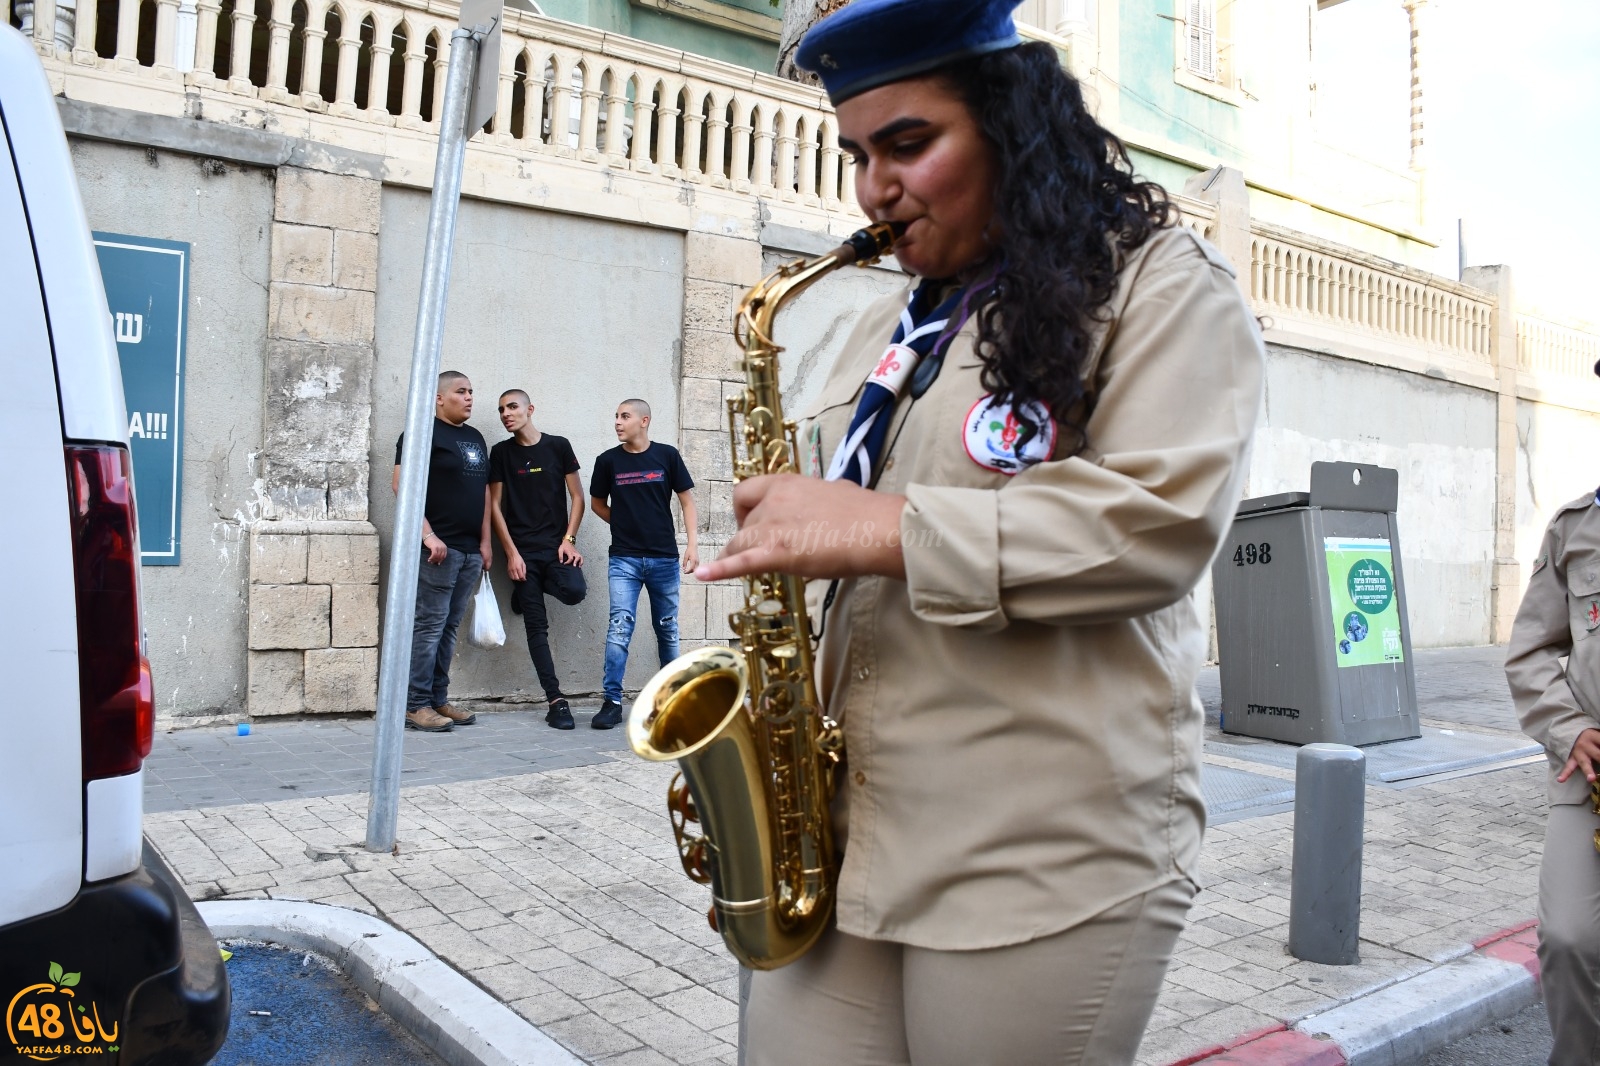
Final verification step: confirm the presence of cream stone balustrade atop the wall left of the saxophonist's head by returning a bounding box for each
[13,0,854,208]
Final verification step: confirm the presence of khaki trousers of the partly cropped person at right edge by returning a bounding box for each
[1539,804,1600,1066]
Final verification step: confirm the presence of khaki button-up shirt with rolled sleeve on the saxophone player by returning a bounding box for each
[802,229,1262,949]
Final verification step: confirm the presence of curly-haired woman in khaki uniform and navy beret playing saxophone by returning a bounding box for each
[698,0,1262,1066]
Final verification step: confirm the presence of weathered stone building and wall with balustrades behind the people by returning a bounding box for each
[13,0,1600,720]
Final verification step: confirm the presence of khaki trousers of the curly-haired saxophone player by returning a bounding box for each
[742,880,1195,1066]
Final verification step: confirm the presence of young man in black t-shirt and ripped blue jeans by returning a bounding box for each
[589,393,699,730]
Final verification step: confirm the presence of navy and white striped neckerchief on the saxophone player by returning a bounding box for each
[824,280,966,488]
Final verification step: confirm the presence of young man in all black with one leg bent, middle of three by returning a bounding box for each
[490,389,586,730]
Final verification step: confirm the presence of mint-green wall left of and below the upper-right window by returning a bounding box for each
[1118,0,1245,166]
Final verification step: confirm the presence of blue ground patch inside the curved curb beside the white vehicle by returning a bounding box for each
[211,944,442,1066]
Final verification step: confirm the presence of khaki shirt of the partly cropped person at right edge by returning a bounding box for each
[1506,493,1600,804]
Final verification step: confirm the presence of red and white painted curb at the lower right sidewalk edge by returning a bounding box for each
[1168,922,1539,1066]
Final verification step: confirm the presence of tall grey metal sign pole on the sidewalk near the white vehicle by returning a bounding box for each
[366,29,480,852]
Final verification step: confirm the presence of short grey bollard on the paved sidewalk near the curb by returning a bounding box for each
[1290,744,1366,967]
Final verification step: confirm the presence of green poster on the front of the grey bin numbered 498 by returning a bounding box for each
[1323,536,1405,666]
